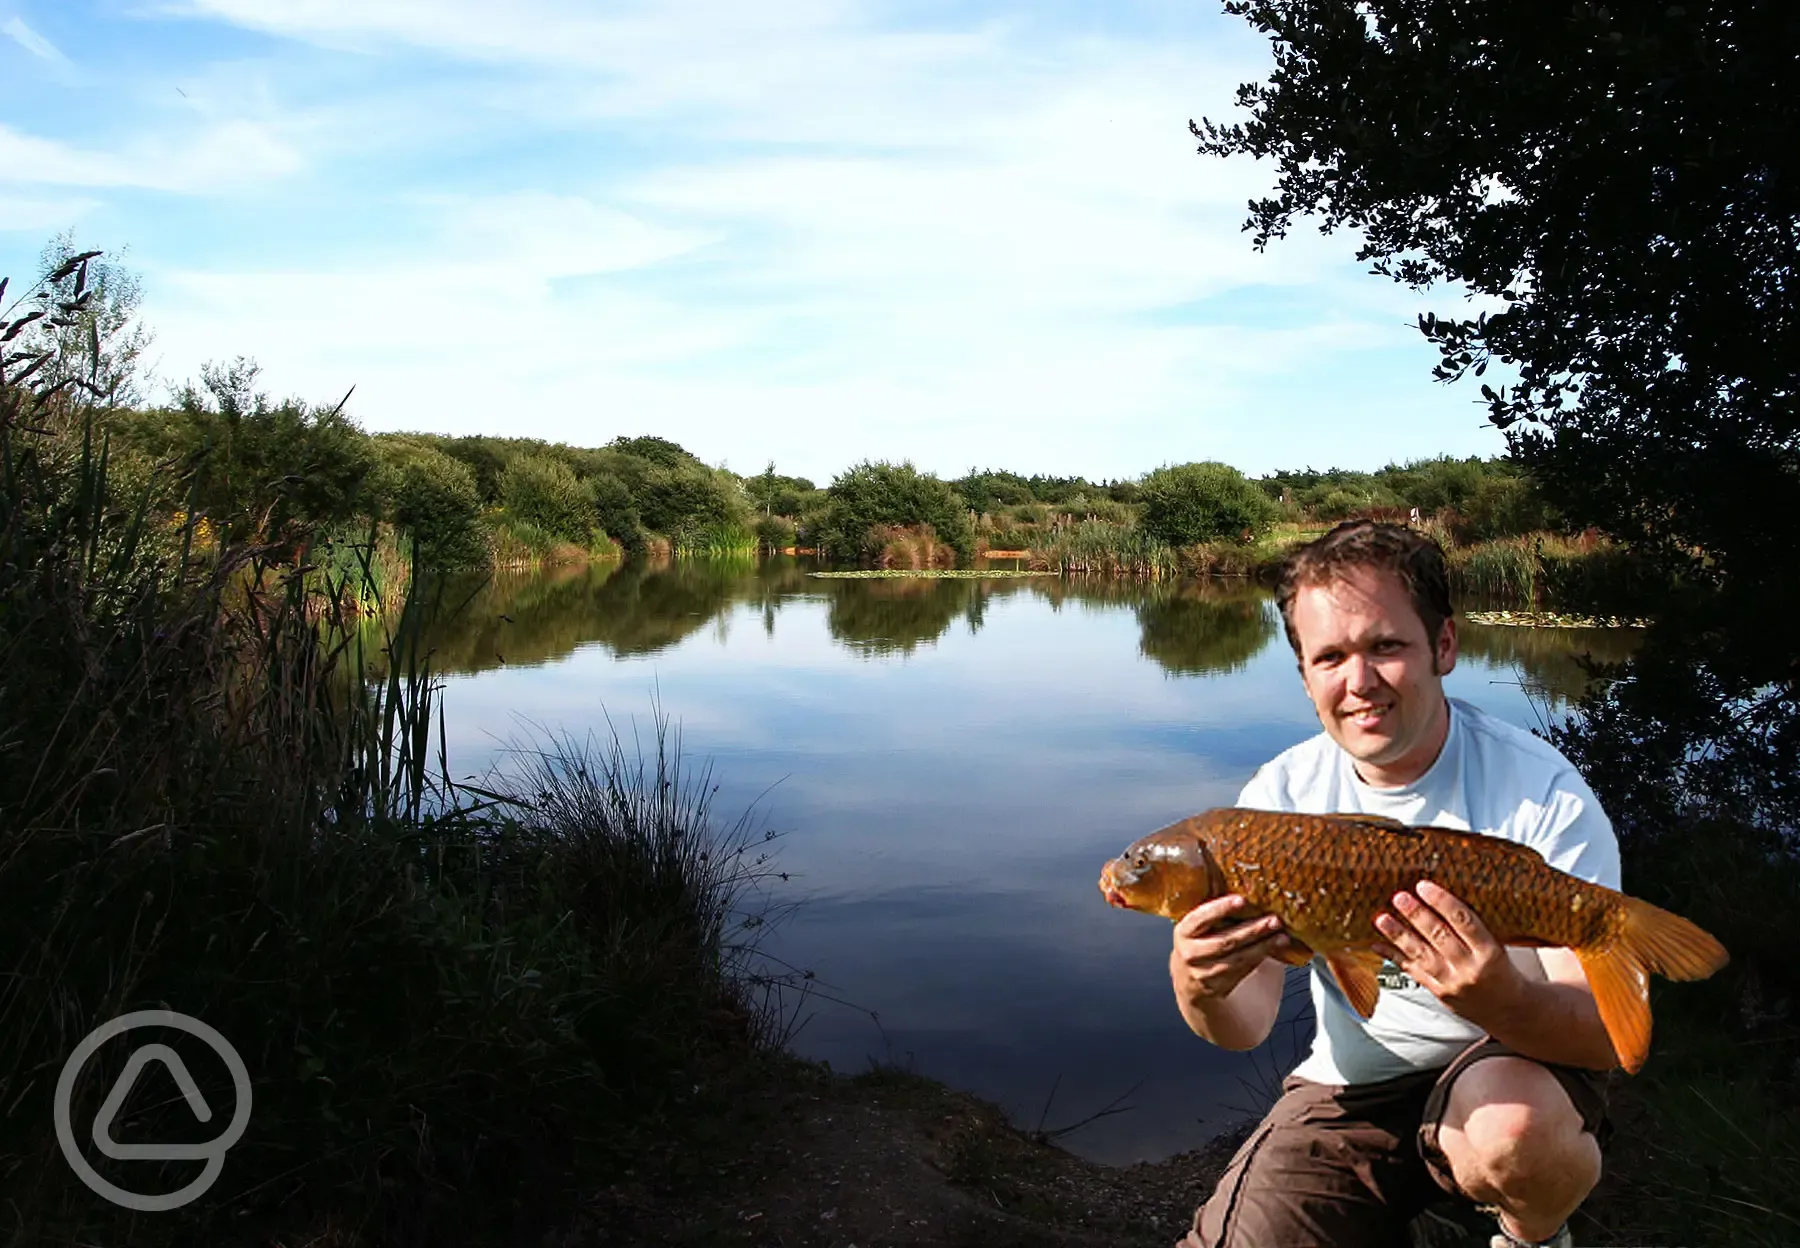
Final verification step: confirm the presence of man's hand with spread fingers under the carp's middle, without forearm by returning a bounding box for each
[1375,881,1525,1032]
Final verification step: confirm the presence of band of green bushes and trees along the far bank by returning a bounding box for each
[31,238,1663,612]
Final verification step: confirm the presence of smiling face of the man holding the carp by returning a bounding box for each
[1292,567,1456,785]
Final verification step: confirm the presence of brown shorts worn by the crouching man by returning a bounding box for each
[1179,1039,1607,1248]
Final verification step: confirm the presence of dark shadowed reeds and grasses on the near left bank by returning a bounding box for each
[0,268,788,1244]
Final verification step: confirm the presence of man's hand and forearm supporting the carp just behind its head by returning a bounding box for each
[1168,893,1287,1048]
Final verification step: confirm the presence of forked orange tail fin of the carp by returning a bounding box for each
[1575,897,1728,1075]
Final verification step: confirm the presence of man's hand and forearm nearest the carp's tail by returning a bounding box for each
[1375,881,1618,1070]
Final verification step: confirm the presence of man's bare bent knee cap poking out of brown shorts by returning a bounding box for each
[1438,1057,1600,1201]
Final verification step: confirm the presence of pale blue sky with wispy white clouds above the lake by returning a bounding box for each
[0,0,1503,483]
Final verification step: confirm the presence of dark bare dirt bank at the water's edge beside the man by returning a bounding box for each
[544,1059,1677,1248]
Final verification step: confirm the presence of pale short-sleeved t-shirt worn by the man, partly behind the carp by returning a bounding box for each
[1238,699,1620,1084]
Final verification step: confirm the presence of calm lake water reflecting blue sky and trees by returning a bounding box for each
[434,560,1634,1163]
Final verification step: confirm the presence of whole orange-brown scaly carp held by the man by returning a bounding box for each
[1100,807,1726,1073]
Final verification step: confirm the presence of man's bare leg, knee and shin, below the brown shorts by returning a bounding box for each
[1424,1055,1600,1243]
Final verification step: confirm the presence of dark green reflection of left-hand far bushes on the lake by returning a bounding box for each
[428,560,799,672]
